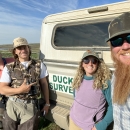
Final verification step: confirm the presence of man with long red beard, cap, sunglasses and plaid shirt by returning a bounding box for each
[107,12,130,130]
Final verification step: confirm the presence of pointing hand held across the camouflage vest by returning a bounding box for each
[19,79,36,93]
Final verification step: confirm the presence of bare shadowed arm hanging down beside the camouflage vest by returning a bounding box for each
[40,77,50,114]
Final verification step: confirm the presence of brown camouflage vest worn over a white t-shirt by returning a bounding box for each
[6,59,41,99]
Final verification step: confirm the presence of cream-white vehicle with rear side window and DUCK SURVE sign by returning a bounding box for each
[40,1,130,130]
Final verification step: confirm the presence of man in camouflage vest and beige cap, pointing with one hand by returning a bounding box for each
[0,37,50,130]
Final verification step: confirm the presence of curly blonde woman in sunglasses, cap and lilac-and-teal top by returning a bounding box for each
[69,50,113,130]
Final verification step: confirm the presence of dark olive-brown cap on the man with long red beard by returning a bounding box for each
[107,12,130,42]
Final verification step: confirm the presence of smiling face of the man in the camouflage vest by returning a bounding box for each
[15,45,29,62]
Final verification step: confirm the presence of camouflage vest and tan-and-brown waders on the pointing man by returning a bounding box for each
[3,60,41,130]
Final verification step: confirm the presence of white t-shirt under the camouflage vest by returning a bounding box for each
[0,61,48,83]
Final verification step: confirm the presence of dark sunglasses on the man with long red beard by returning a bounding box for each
[110,34,130,47]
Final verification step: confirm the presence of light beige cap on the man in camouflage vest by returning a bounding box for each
[13,37,28,48]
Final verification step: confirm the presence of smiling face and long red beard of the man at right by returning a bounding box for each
[111,34,130,104]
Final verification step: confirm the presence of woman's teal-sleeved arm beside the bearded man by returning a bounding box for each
[95,81,113,130]
